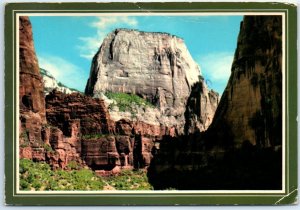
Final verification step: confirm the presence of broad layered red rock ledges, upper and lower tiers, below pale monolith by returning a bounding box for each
[46,90,176,171]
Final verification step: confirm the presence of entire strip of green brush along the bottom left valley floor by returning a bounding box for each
[19,159,153,191]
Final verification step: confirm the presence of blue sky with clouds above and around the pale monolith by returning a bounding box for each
[30,16,242,94]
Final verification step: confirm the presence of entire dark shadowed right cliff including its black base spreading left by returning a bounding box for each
[148,16,282,190]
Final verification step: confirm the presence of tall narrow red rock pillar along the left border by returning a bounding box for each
[19,16,46,160]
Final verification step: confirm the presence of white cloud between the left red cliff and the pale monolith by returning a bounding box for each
[38,55,87,91]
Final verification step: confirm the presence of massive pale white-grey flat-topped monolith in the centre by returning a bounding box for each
[85,29,205,132]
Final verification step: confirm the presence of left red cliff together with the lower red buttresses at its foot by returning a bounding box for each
[19,16,84,168]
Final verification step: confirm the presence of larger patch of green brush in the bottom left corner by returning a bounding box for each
[19,159,104,191]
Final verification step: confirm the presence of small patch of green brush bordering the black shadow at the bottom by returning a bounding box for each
[104,170,153,190]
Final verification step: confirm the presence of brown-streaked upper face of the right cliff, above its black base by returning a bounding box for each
[211,16,282,147]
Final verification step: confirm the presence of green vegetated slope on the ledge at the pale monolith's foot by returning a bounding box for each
[105,92,154,113]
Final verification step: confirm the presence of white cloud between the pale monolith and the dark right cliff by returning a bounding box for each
[198,52,233,81]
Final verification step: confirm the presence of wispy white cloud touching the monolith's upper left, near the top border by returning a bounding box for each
[78,16,138,60]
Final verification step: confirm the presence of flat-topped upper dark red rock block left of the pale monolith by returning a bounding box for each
[46,90,114,136]
